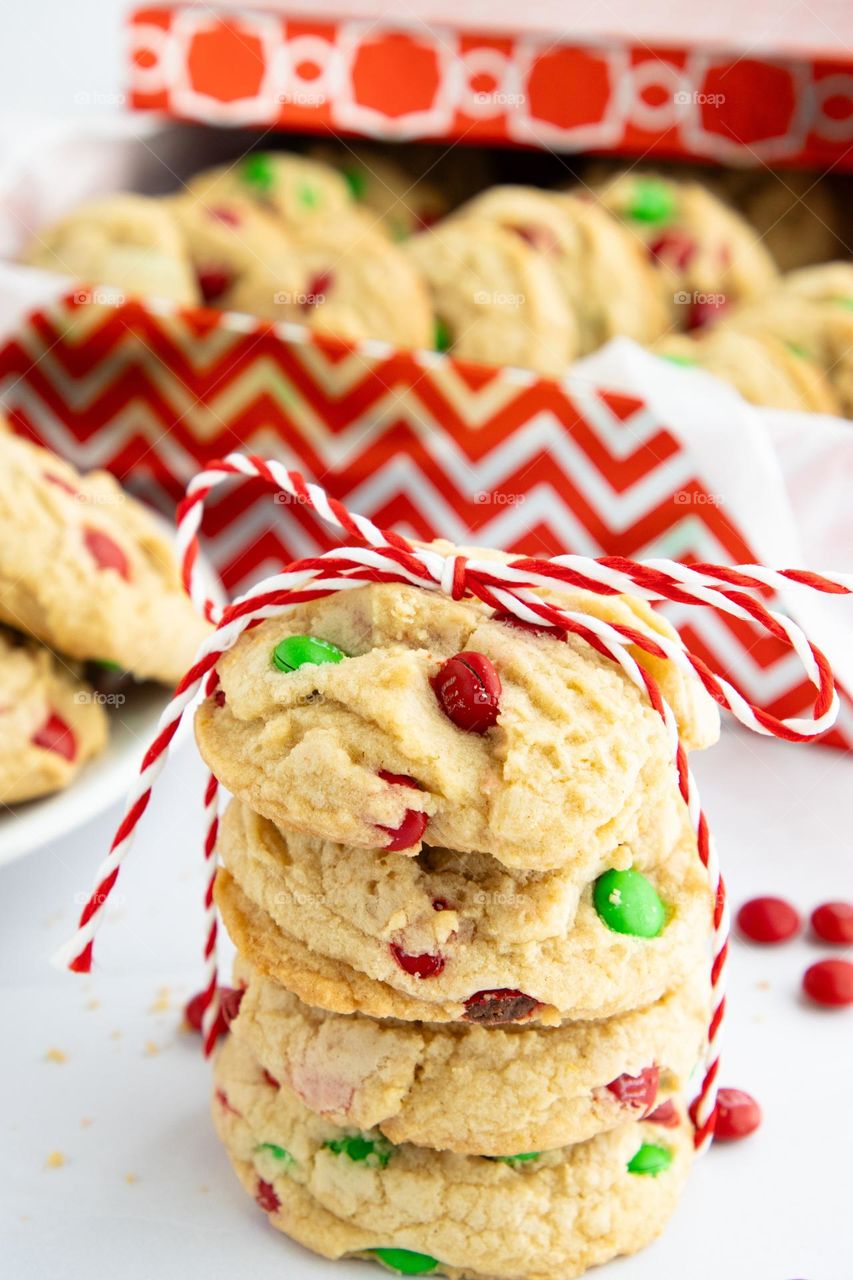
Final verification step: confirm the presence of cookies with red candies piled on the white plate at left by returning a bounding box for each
[0,421,209,805]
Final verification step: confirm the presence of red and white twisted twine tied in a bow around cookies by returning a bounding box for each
[56,453,853,1149]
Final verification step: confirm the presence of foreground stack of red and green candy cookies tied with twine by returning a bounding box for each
[196,558,719,1280]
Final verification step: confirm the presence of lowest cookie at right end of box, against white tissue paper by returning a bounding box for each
[654,325,840,413]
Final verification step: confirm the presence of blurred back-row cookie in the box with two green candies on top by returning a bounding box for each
[186,151,355,230]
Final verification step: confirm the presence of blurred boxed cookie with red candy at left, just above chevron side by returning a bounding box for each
[231,214,434,347]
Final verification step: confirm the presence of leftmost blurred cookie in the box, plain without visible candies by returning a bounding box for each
[23,195,200,306]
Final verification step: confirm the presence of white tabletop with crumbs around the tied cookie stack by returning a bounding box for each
[0,732,853,1280]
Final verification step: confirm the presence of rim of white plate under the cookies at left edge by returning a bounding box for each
[0,684,169,867]
